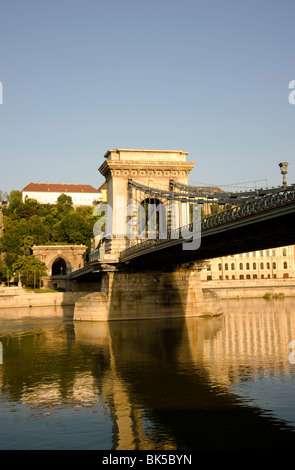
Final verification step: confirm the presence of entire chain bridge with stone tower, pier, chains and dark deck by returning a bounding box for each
[70,149,295,320]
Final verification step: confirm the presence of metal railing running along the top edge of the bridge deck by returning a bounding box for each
[120,185,295,259]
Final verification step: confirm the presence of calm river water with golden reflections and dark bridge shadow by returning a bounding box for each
[0,298,295,450]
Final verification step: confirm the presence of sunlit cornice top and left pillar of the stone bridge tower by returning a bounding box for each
[99,149,195,259]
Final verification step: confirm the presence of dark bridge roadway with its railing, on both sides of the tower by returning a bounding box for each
[71,186,295,280]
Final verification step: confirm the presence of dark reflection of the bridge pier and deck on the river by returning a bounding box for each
[105,319,295,450]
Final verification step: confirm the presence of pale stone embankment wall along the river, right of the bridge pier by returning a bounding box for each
[202,279,295,299]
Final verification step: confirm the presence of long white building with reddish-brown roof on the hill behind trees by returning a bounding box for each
[22,182,102,206]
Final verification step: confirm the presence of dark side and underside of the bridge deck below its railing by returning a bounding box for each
[120,195,295,267]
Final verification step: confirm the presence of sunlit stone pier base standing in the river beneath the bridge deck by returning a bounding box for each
[74,263,222,321]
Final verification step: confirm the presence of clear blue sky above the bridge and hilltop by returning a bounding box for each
[0,0,295,192]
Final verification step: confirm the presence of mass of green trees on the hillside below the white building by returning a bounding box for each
[0,187,96,262]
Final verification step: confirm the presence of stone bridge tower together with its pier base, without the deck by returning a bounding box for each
[74,149,220,320]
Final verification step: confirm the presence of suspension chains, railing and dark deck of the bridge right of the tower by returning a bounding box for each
[119,182,295,267]
